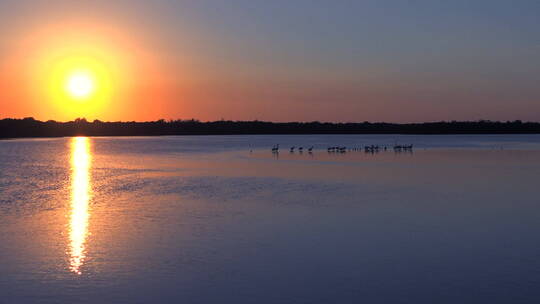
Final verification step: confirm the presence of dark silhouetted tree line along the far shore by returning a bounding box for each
[0,117,540,138]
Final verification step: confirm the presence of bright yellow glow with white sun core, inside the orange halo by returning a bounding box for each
[32,40,124,120]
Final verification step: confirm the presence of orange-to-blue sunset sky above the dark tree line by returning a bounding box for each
[0,0,540,122]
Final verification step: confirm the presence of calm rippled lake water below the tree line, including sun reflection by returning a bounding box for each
[0,135,540,304]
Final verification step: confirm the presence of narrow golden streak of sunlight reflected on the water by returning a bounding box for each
[69,137,91,274]
